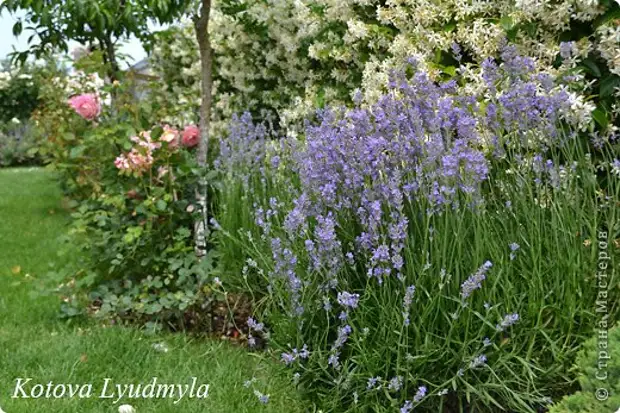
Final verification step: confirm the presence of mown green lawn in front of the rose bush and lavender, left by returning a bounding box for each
[0,168,302,413]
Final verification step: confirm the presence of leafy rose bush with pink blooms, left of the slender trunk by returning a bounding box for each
[30,55,217,328]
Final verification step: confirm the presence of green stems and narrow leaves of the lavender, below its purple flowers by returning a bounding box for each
[218,142,620,413]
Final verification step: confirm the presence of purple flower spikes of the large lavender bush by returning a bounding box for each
[216,50,568,402]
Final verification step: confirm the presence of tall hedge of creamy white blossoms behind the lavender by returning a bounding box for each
[153,0,620,130]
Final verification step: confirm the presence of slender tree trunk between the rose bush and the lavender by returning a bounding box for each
[194,0,213,257]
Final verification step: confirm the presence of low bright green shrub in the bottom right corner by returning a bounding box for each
[549,322,620,413]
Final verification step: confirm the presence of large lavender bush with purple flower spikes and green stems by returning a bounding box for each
[217,48,620,413]
